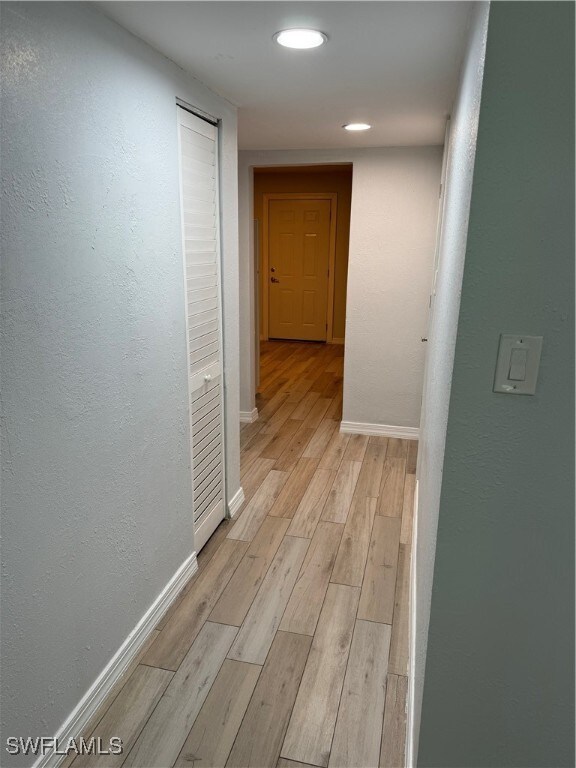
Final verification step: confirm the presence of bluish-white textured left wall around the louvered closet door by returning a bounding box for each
[1,3,239,765]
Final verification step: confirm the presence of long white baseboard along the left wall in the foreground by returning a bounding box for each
[34,552,198,768]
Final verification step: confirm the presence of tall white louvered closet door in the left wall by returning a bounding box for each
[178,107,225,551]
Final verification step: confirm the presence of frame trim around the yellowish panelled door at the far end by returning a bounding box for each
[261,192,338,344]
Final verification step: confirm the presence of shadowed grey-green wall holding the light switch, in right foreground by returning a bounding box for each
[418,2,574,768]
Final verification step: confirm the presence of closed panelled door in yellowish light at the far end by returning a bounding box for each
[268,197,331,341]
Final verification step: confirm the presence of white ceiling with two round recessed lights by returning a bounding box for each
[98,0,471,149]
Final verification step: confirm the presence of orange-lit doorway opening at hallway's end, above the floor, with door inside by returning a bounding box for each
[254,163,352,400]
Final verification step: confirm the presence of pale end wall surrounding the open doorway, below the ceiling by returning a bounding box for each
[239,147,442,428]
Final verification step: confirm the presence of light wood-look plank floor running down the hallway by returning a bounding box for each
[67,342,417,768]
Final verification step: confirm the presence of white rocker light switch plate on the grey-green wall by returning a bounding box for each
[493,333,542,395]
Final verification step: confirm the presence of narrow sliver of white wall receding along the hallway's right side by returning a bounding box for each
[408,2,489,766]
